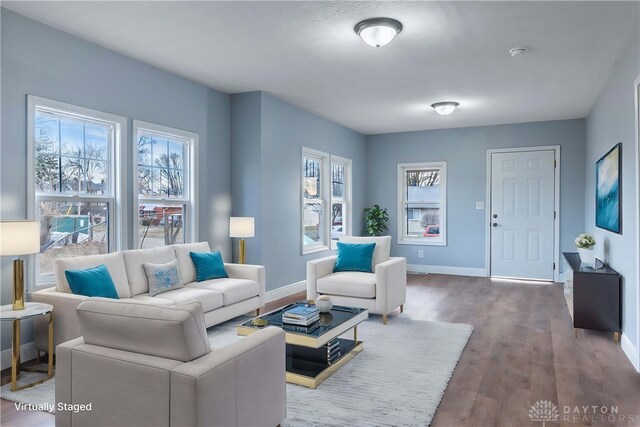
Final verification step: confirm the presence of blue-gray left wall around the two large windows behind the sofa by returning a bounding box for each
[0,9,230,349]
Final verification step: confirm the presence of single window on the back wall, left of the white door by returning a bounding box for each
[398,162,447,246]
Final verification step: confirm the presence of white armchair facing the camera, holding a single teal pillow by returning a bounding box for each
[307,236,407,325]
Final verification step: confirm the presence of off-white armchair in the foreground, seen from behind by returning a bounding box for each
[55,298,286,427]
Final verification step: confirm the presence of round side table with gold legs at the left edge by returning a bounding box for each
[0,302,53,391]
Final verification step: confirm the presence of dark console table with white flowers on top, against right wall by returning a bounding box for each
[562,252,621,342]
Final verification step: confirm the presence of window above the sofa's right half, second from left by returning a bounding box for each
[134,121,198,248]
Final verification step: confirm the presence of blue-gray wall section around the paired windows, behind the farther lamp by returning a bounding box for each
[231,92,366,290]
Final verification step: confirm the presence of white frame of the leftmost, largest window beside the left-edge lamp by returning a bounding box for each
[27,95,127,290]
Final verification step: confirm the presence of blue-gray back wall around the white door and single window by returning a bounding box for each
[366,119,585,268]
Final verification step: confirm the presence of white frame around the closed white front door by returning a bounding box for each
[485,145,562,282]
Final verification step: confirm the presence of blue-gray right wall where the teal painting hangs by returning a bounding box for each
[584,28,640,357]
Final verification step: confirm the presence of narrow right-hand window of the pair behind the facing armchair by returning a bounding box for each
[331,156,351,248]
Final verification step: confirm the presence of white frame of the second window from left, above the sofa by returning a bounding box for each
[131,120,200,249]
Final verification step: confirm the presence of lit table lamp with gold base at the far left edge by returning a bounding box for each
[0,220,40,310]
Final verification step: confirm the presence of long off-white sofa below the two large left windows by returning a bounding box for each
[31,242,265,351]
